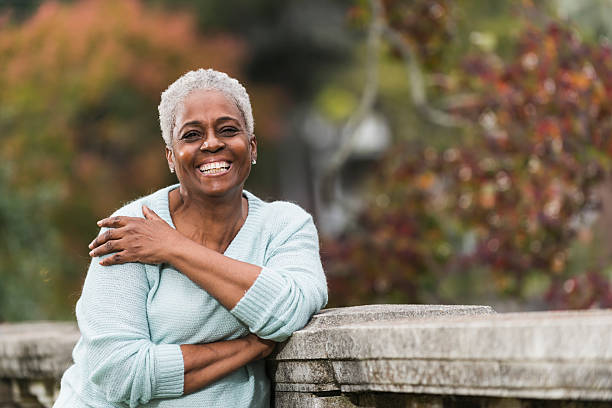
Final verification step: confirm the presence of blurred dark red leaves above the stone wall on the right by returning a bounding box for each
[327,18,612,308]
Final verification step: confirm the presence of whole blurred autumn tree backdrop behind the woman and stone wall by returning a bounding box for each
[0,0,612,322]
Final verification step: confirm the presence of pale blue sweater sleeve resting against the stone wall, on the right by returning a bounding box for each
[231,206,327,342]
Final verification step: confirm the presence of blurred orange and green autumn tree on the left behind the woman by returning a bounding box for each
[0,0,244,320]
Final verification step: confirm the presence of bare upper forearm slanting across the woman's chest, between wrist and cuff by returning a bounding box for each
[166,239,261,310]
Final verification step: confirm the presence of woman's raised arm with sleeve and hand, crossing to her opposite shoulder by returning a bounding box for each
[90,205,327,341]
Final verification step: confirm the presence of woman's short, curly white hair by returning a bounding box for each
[157,68,255,146]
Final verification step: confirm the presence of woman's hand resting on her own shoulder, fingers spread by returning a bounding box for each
[89,205,185,266]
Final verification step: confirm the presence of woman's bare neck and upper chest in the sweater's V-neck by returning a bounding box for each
[169,186,248,253]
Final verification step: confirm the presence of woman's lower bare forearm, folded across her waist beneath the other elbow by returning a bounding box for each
[181,335,274,394]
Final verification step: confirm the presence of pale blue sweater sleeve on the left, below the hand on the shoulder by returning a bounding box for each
[77,210,184,407]
